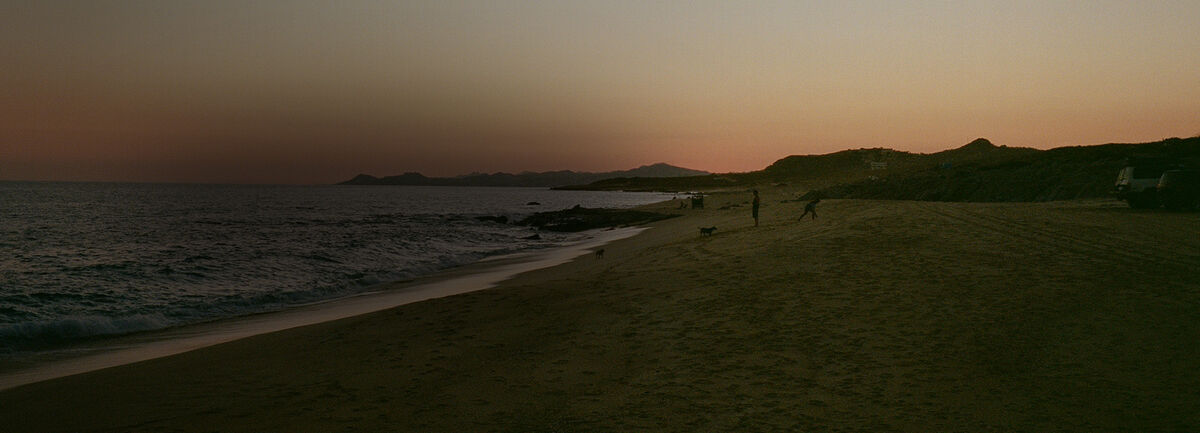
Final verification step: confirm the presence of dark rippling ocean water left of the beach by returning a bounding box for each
[0,182,671,360]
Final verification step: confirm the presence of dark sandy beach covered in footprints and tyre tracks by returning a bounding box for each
[0,191,1200,432]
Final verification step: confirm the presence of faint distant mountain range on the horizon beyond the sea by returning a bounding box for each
[337,163,708,187]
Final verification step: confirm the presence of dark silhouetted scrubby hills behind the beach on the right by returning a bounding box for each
[568,137,1200,202]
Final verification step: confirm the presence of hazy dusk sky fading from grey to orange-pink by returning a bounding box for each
[0,0,1200,184]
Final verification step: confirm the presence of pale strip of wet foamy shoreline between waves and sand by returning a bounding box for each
[0,227,646,391]
